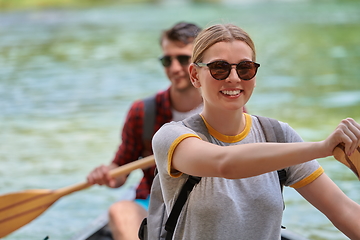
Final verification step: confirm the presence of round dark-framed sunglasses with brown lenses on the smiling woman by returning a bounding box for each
[195,61,260,81]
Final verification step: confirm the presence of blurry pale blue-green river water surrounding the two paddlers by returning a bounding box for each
[0,1,360,240]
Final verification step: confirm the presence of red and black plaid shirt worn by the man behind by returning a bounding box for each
[113,89,172,199]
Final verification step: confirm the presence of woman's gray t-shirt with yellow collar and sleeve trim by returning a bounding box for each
[153,114,323,240]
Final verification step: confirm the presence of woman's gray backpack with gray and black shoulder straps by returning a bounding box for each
[138,116,286,240]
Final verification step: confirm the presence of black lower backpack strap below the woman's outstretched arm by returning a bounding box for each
[165,175,201,240]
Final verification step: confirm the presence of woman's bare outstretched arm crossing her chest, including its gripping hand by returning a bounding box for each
[171,118,360,179]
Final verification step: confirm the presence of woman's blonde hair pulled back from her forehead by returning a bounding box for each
[192,24,256,63]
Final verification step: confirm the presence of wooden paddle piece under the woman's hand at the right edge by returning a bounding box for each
[333,144,360,180]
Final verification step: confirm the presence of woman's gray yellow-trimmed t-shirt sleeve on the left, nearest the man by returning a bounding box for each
[152,122,201,177]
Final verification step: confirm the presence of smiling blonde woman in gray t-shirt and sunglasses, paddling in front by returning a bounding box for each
[153,24,360,240]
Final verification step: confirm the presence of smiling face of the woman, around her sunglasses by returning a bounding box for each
[190,40,255,110]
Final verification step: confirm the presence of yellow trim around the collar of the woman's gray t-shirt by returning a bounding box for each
[200,113,252,143]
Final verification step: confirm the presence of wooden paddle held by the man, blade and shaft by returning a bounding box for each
[0,155,155,238]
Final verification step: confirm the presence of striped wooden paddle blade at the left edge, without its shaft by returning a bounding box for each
[0,189,59,238]
